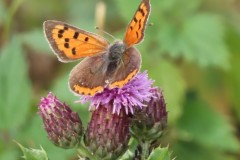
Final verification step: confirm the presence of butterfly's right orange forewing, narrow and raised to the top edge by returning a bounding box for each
[123,0,151,47]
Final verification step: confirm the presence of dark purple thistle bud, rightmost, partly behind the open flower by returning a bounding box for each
[130,88,167,142]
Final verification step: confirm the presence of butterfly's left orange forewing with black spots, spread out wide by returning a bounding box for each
[43,20,109,62]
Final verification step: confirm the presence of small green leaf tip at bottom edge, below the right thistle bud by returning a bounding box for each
[148,147,172,160]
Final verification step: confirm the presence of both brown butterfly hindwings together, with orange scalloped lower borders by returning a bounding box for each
[69,47,141,96]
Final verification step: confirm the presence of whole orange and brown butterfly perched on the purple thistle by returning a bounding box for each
[43,0,150,96]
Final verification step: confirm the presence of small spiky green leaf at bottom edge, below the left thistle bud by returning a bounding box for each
[16,142,48,160]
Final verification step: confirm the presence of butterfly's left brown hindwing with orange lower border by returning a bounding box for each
[69,55,107,96]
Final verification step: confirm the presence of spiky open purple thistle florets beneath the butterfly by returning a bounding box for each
[80,71,153,114]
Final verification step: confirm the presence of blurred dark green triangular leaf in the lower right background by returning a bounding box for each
[177,96,240,153]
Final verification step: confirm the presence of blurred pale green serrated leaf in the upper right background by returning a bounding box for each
[158,13,229,68]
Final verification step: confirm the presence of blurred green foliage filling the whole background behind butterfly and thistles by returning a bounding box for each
[0,0,240,160]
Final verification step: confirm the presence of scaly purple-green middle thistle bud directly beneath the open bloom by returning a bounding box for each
[84,106,130,160]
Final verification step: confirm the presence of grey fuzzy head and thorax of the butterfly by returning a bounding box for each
[109,41,126,61]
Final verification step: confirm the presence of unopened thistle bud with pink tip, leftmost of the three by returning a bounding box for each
[38,92,83,148]
